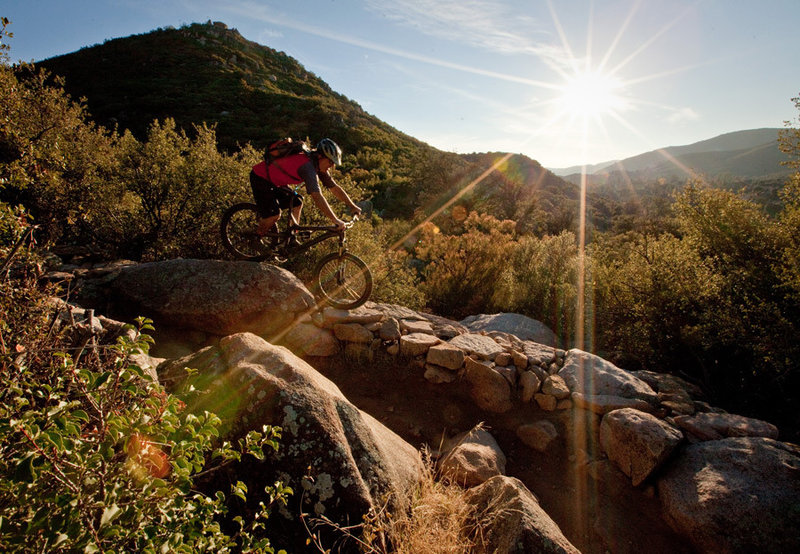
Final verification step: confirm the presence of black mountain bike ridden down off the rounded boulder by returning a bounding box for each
[220,192,372,310]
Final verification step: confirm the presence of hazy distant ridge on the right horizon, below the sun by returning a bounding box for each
[553,128,790,184]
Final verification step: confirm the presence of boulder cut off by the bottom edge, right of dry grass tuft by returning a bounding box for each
[465,475,579,554]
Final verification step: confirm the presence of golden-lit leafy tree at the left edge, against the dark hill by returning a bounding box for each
[0,58,115,246]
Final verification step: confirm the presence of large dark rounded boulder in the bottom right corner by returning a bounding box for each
[658,437,800,554]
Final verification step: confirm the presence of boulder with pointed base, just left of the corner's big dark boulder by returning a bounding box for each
[600,408,683,486]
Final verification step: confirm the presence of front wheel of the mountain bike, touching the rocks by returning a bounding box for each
[312,252,372,310]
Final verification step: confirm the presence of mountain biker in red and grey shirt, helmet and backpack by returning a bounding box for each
[250,138,361,237]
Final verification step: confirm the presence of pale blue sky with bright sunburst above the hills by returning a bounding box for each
[0,0,800,167]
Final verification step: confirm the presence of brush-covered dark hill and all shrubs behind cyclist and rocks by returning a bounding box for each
[0,20,800,452]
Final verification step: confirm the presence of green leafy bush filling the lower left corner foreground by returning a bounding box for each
[0,201,291,552]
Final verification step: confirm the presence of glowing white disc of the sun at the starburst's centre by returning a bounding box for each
[558,70,624,118]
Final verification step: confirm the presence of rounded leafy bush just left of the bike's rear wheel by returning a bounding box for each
[111,119,258,260]
